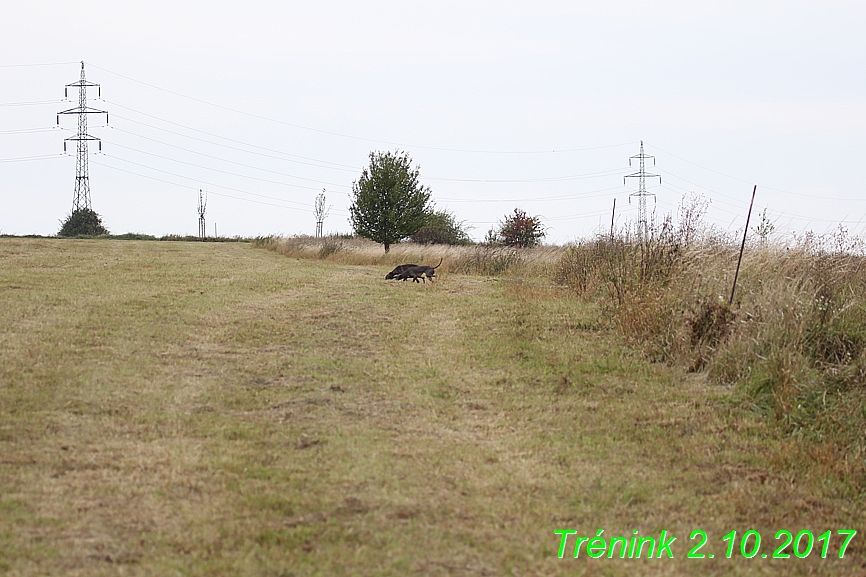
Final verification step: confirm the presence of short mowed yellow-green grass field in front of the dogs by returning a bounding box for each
[0,239,866,577]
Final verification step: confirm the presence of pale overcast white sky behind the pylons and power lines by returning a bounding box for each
[0,0,866,243]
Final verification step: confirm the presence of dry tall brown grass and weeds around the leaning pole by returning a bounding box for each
[555,220,866,492]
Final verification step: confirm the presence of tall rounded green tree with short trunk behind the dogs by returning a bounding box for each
[349,151,433,252]
